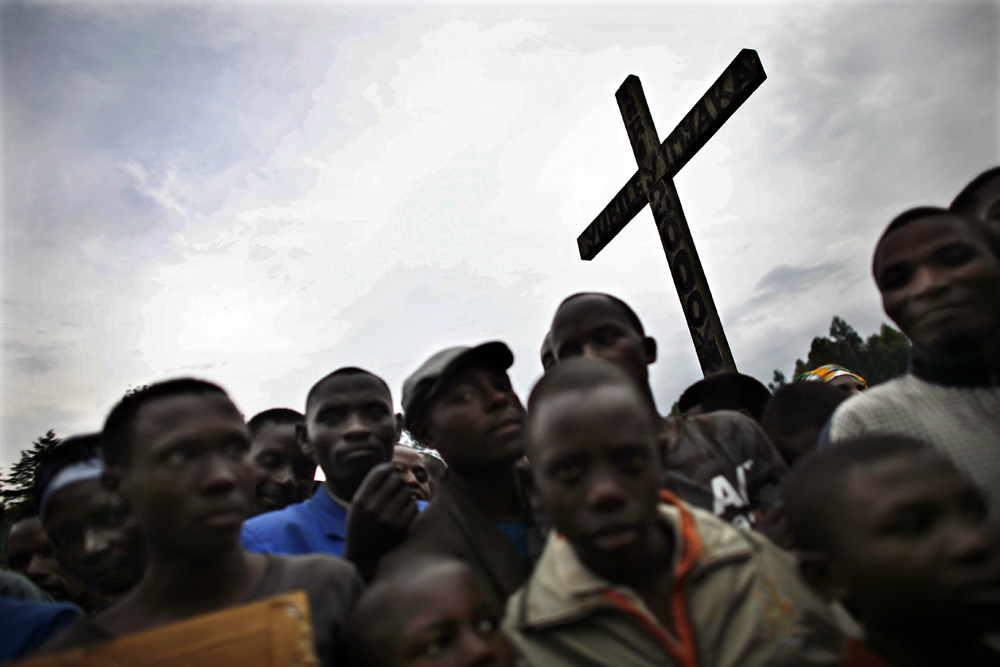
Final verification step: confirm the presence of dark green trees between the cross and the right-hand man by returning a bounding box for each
[768,316,910,391]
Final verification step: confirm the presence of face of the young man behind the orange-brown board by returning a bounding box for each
[120,393,253,557]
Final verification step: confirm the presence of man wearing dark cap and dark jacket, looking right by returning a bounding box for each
[379,342,540,604]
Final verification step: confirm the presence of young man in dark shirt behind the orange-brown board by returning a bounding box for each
[36,379,362,665]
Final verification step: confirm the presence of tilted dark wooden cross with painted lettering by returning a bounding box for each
[576,49,767,377]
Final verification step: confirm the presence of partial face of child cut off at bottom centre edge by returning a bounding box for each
[382,563,514,667]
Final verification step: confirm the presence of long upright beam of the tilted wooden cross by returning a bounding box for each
[615,75,736,377]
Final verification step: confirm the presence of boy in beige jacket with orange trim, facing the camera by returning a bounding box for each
[504,359,844,666]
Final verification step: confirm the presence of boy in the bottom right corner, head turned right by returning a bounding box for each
[786,436,1000,667]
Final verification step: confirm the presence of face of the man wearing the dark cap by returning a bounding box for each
[424,365,524,470]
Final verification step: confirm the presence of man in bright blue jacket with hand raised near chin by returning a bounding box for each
[240,367,418,578]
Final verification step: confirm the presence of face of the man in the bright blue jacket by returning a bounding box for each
[305,373,399,500]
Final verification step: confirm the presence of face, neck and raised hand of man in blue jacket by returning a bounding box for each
[298,373,418,580]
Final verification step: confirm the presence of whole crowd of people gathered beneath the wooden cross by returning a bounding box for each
[0,168,1000,667]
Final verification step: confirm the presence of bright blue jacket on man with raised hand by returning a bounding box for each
[240,484,427,556]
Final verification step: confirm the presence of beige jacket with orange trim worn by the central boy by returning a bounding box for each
[504,494,847,667]
